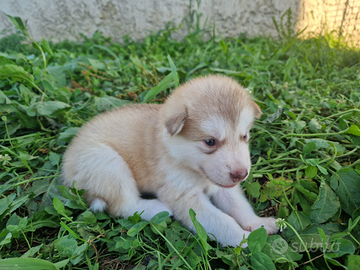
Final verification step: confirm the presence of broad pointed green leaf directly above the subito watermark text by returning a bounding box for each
[310,180,340,223]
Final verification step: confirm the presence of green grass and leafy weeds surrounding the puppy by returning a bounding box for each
[0,15,360,269]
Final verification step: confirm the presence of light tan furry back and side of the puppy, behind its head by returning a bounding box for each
[62,104,160,188]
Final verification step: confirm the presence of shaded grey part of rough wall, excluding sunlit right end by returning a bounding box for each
[0,0,298,41]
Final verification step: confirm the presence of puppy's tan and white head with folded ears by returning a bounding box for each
[161,75,261,187]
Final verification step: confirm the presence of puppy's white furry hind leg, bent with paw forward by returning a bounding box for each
[64,144,172,220]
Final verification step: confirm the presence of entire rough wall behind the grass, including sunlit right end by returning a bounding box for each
[0,0,360,43]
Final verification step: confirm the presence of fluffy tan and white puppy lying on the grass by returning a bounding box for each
[62,75,277,246]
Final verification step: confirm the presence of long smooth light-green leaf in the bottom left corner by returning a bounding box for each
[0,258,58,270]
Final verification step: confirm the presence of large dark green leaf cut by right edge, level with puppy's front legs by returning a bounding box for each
[330,168,360,215]
